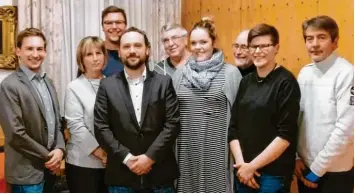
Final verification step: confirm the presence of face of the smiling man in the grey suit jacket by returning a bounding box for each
[16,36,47,72]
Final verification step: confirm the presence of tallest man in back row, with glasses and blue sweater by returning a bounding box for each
[101,6,127,77]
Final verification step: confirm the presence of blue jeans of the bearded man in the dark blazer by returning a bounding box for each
[108,186,175,193]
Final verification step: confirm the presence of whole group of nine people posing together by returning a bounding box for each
[0,6,354,192]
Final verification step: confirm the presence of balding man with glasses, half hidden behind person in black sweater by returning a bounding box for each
[232,30,255,77]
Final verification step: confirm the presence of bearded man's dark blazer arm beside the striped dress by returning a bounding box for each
[146,78,180,161]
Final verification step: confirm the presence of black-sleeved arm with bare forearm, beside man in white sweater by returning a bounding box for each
[251,81,301,169]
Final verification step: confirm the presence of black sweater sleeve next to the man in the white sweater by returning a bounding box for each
[277,80,301,143]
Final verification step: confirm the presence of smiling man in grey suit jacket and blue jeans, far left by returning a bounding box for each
[0,28,65,193]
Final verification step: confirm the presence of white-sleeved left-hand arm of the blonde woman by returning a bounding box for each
[65,86,99,156]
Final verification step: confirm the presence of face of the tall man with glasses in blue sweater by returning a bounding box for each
[102,12,126,43]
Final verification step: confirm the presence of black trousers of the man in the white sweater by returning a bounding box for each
[298,168,354,193]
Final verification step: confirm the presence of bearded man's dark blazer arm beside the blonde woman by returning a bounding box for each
[94,80,129,162]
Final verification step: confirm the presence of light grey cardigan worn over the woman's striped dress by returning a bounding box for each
[172,64,242,193]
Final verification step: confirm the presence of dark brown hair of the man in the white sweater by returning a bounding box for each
[302,15,339,42]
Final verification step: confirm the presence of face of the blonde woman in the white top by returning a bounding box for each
[83,45,105,73]
